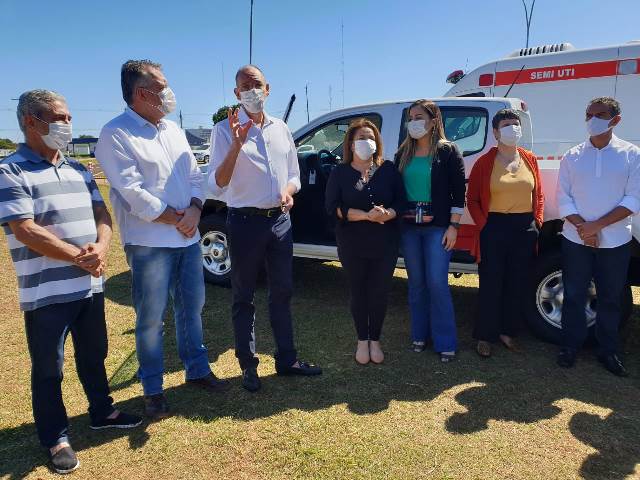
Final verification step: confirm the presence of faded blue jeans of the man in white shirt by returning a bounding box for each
[124,243,211,395]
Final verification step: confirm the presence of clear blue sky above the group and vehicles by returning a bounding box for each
[0,0,640,140]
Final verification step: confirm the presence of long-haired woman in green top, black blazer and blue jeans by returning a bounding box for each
[396,100,465,362]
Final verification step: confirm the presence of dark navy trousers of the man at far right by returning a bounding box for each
[562,238,631,355]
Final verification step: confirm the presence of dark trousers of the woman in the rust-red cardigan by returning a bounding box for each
[473,213,538,342]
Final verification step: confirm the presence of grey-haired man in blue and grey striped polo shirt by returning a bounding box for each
[0,90,141,473]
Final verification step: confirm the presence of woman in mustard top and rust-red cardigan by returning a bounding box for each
[467,109,544,357]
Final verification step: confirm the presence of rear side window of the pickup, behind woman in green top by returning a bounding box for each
[398,107,489,156]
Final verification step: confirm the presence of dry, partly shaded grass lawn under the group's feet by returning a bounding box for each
[0,187,640,480]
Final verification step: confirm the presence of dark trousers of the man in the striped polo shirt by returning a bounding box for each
[24,293,114,448]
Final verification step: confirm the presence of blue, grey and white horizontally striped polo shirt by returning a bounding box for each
[0,144,104,311]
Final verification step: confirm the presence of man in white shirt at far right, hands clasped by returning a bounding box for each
[557,97,640,376]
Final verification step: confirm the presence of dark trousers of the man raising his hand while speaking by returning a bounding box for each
[227,211,297,370]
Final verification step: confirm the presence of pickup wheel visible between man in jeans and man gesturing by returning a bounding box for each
[198,213,231,287]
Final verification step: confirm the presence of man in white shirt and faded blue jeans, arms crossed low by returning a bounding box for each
[95,60,229,419]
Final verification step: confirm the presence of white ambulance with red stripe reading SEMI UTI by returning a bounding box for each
[444,41,640,218]
